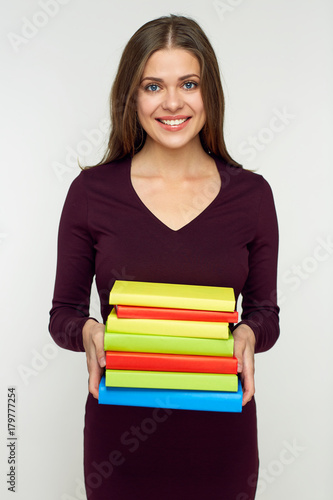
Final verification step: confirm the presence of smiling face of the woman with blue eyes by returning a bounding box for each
[137,49,206,149]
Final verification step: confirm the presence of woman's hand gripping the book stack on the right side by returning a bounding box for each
[232,325,256,406]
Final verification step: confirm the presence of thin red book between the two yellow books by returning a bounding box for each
[115,305,238,323]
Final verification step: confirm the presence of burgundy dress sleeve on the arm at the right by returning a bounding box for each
[236,178,279,352]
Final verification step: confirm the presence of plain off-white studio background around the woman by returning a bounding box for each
[0,0,333,500]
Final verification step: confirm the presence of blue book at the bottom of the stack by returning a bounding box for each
[98,375,243,413]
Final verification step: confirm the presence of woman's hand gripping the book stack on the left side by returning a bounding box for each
[82,319,106,399]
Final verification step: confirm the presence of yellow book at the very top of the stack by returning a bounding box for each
[110,280,236,311]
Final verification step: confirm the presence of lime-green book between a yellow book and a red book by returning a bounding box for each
[104,332,234,356]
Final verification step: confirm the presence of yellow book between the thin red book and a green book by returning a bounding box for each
[106,309,229,339]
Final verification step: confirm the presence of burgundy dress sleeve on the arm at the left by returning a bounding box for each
[49,172,95,351]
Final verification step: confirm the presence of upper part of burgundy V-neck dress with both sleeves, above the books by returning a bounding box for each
[50,158,279,352]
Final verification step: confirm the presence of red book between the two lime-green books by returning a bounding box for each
[106,351,237,374]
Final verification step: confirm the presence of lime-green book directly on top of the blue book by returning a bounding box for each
[105,370,238,392]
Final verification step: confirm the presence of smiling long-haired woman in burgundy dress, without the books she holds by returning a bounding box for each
[50,16,279,500]
